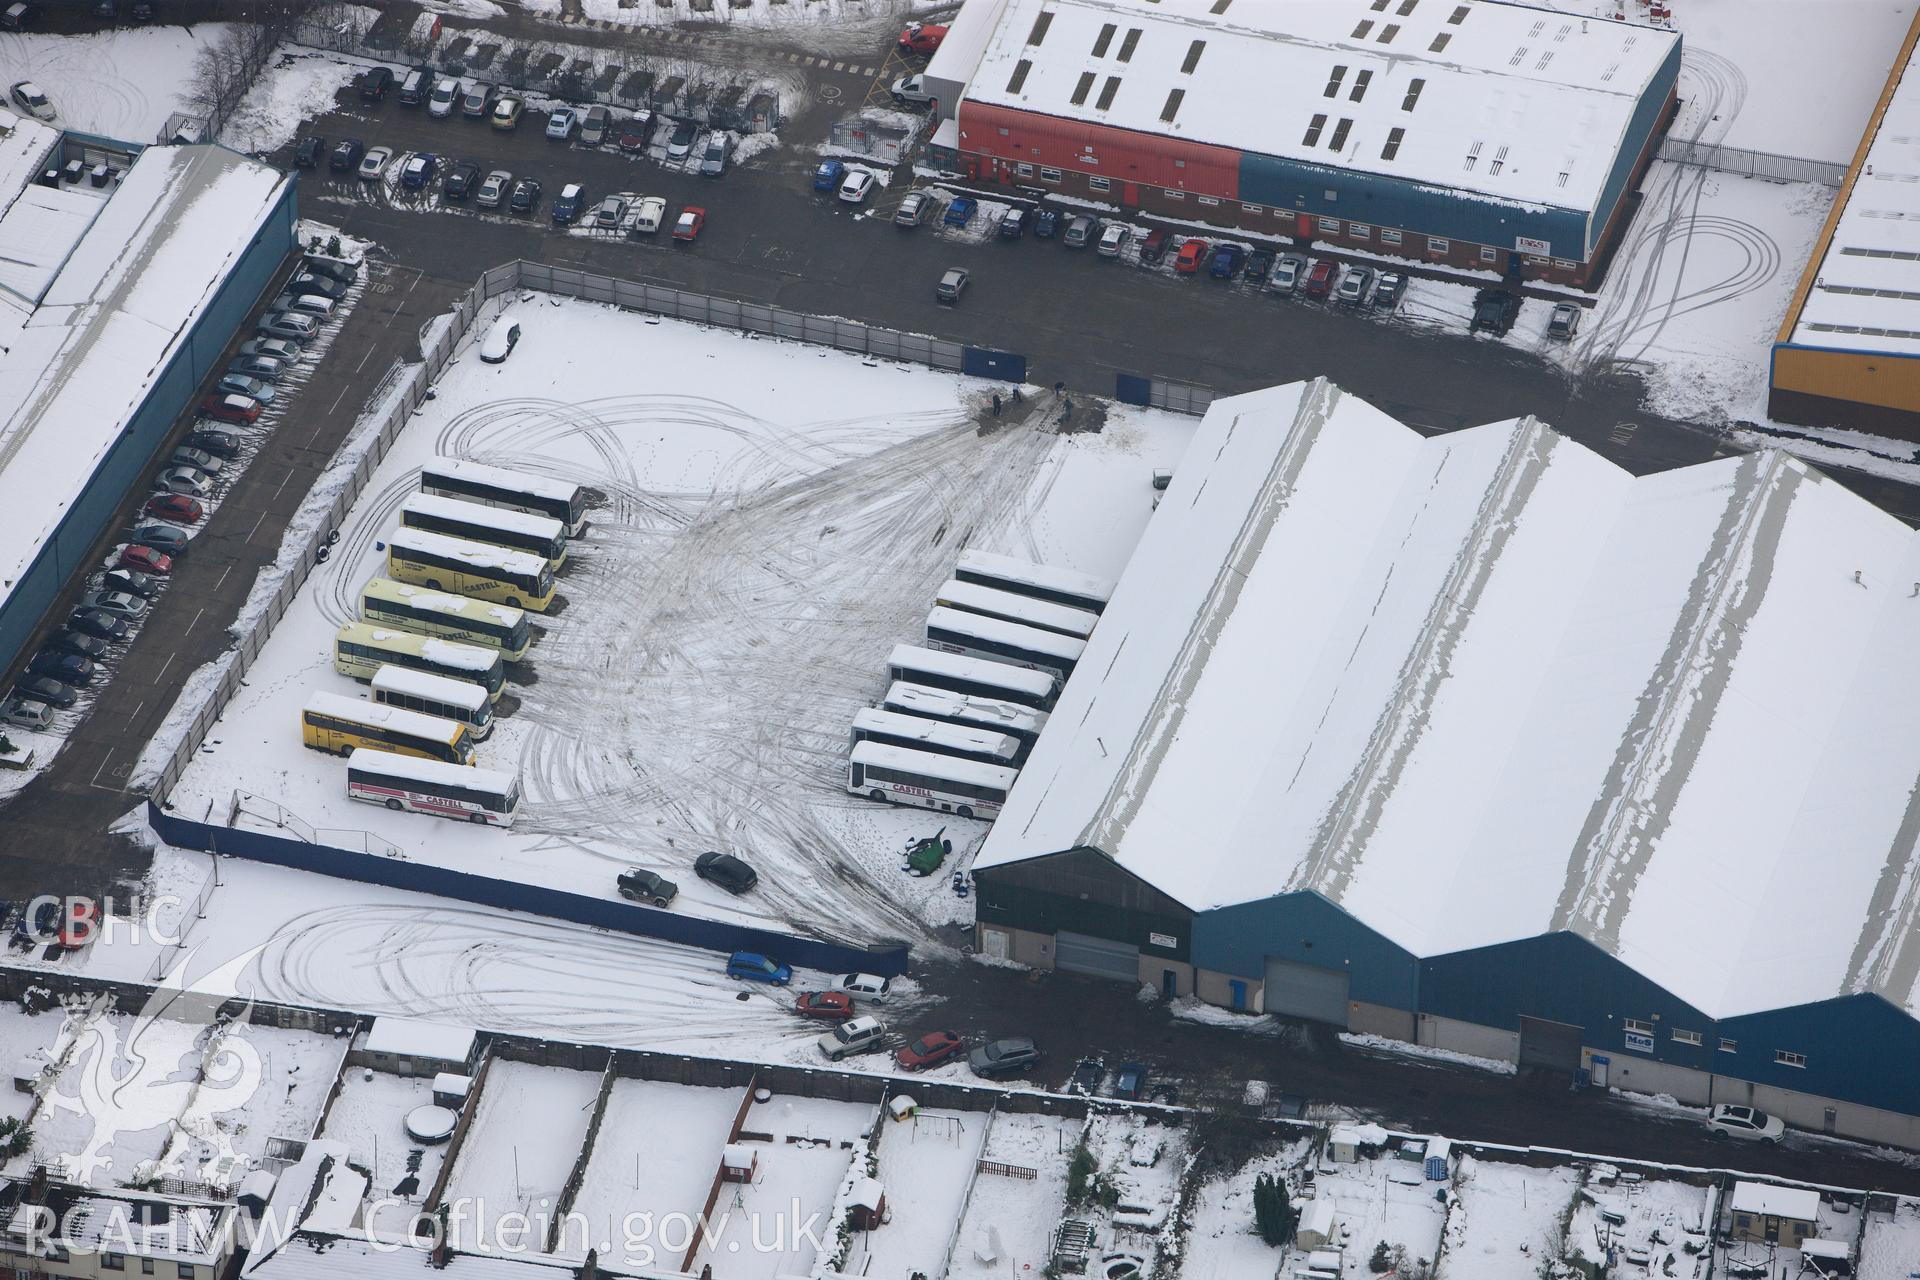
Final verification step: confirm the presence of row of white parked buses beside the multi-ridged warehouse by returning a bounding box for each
[847,551,1114,818]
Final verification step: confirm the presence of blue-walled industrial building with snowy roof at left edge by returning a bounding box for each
[0,109,296,668]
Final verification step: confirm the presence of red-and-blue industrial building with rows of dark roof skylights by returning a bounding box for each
[944,0,1680,284]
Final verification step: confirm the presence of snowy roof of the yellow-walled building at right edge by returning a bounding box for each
[1791,17,1920,355]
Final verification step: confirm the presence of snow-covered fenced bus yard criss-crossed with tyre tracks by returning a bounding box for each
[157,296,1192,940]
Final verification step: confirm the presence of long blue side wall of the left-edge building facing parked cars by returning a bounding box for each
[0,165,298,666]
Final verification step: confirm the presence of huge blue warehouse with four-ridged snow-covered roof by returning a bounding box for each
[973,382,1920,1146]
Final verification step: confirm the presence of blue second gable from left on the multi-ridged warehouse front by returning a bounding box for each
[1192,892,1419,1009]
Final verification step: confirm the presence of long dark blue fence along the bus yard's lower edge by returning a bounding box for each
[146,802,910,977]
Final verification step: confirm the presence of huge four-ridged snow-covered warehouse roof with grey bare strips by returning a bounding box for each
[977,382,1920,1017]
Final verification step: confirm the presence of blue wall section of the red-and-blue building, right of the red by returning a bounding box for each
[1240,152,1588,261]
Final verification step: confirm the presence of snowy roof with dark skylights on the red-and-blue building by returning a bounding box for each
[966,0,1680,209]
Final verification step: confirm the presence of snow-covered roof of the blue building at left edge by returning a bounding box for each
[0,139,290,629]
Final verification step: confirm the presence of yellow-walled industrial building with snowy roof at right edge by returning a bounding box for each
[1766,5,1920,439]
